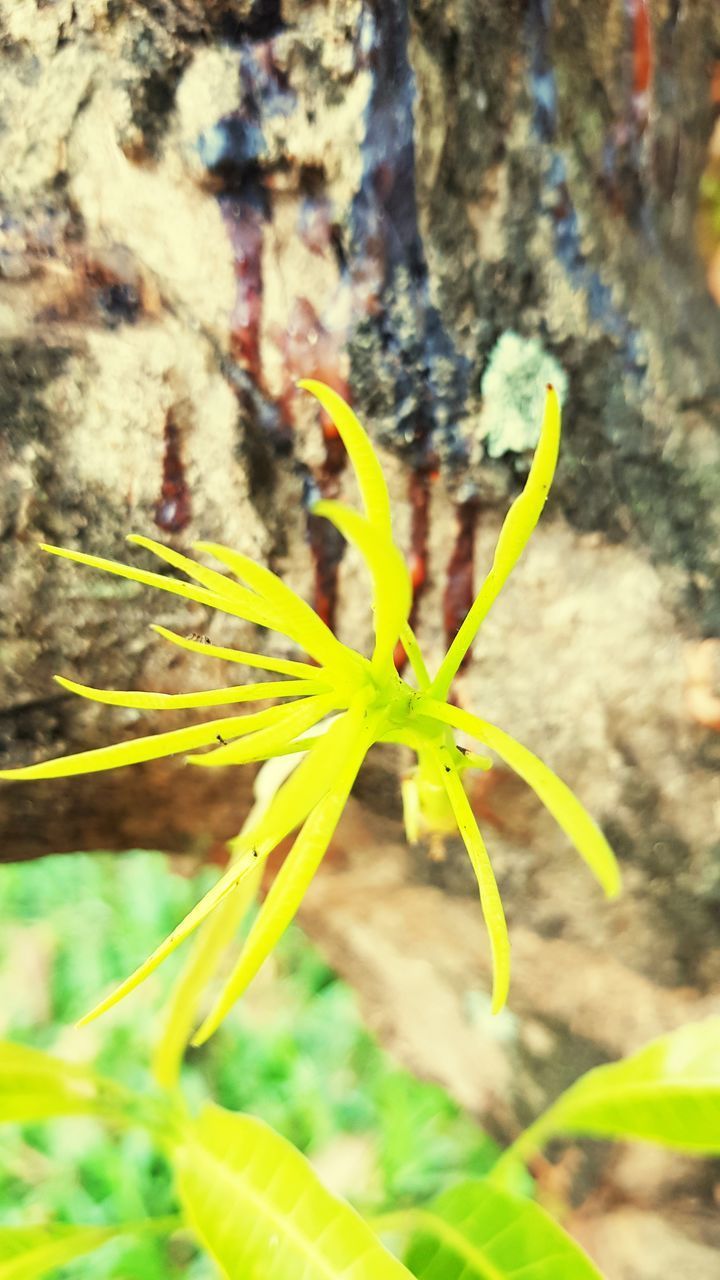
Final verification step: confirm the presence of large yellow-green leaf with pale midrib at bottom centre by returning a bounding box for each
[177,1106,409,1280]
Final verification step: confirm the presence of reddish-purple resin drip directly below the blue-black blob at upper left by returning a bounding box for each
[220,196,264,385]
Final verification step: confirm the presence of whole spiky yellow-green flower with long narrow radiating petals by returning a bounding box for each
[0,381,620,1043]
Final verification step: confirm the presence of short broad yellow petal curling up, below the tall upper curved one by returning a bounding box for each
[314,500,413,667]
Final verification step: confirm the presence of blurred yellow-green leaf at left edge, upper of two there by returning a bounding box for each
[0,1041,131,1124]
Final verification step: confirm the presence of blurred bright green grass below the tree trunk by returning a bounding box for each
[0,851,497,1280]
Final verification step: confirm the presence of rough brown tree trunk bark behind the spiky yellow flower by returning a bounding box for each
[0,0,720,1277]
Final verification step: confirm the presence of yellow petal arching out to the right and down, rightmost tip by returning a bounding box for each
[423,701,620,897]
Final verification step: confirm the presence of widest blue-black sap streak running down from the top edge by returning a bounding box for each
[347,0,470,465]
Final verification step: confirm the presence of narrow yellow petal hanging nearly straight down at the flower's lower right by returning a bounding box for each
[430,746,510,1014]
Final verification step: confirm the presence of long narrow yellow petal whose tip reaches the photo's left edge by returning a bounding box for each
[0,707,257,782]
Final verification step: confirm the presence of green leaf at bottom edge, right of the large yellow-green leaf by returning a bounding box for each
[394,1181,600,1280]
